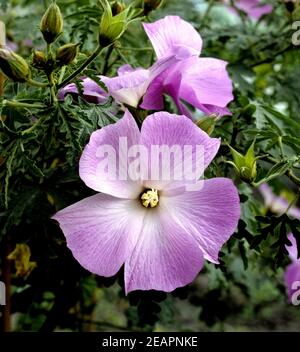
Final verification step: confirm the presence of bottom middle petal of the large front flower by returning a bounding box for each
[125,207,203,293]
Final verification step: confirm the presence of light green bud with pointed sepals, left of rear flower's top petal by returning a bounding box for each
[99,0,129,48]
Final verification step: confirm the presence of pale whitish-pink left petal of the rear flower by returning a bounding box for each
[101,56,178,107]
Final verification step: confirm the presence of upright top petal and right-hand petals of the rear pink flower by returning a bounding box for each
[141,16,233,115]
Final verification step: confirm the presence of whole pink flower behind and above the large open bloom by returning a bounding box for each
[61,16,233,117]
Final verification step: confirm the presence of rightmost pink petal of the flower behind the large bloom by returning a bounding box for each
[179,58,233,110]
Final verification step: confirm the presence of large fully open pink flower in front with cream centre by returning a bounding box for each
[54,111,240,292]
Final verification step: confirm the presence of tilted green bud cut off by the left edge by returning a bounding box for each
[0,49,30,82]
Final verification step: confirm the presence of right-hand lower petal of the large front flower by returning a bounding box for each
[161,178,240,263]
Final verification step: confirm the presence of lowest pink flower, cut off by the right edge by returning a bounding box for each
[284,234,300,303]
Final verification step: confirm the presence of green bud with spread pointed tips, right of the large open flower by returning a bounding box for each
[228,141,258,183]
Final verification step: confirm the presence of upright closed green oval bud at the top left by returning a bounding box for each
[40,1,63,44]
